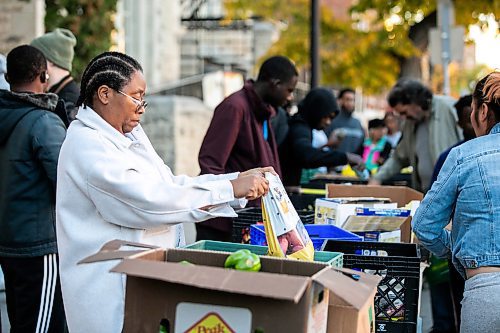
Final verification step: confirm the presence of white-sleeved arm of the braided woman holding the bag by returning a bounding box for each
[81,143,244,229]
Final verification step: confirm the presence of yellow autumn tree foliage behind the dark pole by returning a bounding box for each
[225,0,500,93]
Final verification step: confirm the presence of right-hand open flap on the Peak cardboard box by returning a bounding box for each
[313,267,382,310]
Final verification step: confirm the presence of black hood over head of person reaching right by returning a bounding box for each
[298,88,339,129]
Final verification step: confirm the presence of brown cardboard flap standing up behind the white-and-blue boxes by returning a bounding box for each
[326,184,424,207]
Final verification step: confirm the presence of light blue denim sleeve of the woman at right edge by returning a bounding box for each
[412,149,459,258]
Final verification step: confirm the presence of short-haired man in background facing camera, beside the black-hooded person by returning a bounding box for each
[325,88,365,154]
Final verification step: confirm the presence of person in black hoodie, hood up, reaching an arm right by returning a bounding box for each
[279,88,364,186]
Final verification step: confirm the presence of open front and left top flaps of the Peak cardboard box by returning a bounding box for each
[79,240,340,303]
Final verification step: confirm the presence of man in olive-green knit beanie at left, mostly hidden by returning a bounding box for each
[31,28,80,122]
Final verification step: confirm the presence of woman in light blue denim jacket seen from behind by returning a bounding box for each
[413,72,500,332]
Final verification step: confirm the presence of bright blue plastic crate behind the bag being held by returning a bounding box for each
[250,224,363,251]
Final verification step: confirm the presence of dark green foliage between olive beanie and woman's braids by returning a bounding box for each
[45,0,117,80]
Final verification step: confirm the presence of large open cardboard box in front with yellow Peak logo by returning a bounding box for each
[81,241,380,333]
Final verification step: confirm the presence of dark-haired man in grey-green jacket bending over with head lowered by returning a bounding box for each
[369,79,462,193]
